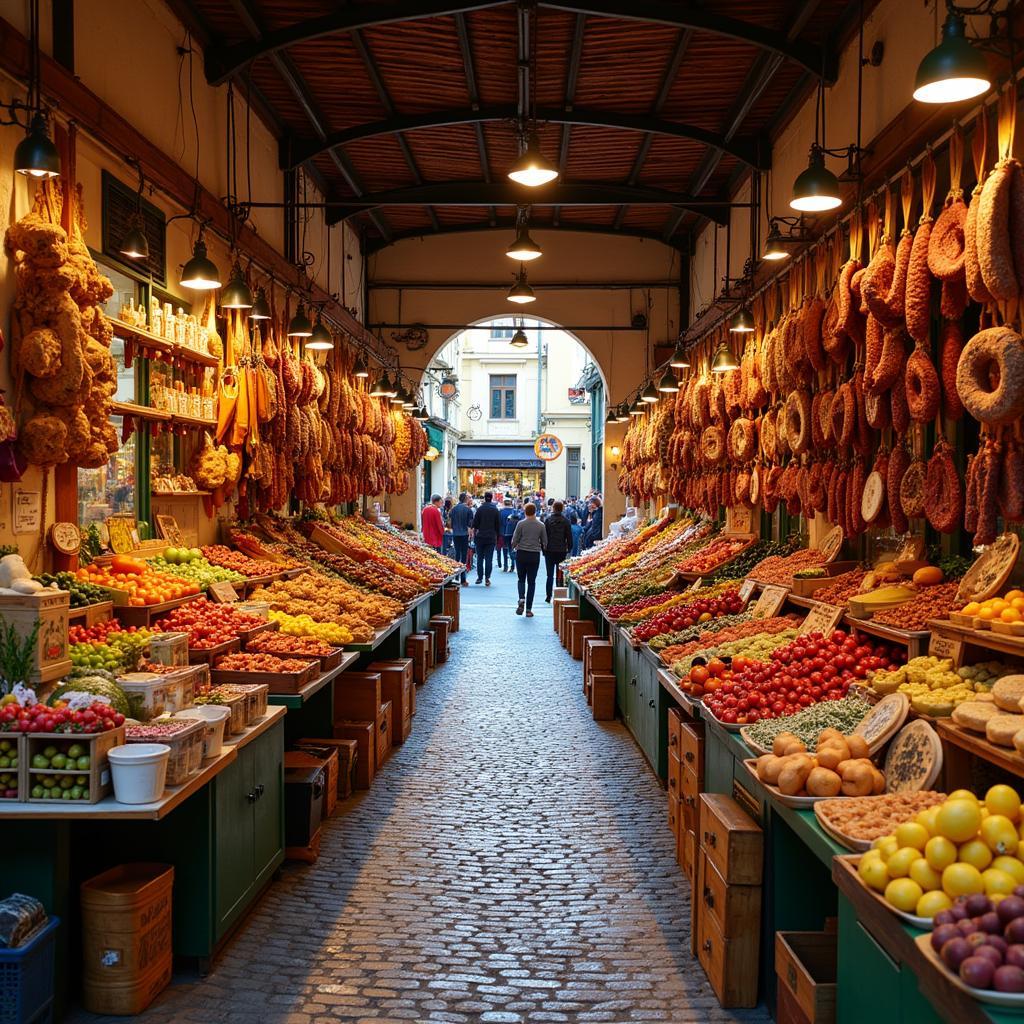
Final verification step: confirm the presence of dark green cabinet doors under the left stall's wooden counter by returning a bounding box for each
[212,729,285,942]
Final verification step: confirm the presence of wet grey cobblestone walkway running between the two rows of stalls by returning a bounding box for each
[76,573,769,1024]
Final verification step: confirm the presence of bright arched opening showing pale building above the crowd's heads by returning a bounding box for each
[423,314,606,499]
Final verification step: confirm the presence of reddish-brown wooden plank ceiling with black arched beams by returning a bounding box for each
[169,0,860,251]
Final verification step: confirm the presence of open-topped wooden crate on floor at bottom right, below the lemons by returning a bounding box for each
[775,931,837,1024]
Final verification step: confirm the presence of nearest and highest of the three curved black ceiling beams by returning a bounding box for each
[205,0,839,85]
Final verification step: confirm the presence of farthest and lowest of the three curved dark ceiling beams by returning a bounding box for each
[323,181,733,227]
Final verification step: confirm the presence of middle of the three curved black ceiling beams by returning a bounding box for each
[280,104,767,170]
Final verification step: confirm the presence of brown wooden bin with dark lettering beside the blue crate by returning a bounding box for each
[82,863,174,1015]
